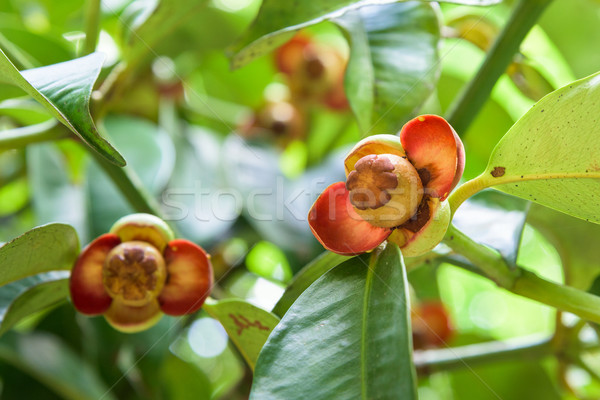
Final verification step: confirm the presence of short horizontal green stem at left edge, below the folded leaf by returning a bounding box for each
[0,119,70,151]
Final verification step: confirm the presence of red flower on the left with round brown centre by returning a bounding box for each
[69,214,213,332]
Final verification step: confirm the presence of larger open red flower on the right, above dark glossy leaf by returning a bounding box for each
[308,115,465,257]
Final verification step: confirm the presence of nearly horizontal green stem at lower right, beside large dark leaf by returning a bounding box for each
[414,338,554,374]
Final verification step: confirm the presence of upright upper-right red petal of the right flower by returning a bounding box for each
[400,115,465,200]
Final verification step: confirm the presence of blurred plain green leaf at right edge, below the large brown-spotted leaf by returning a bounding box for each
[527,205,600,290]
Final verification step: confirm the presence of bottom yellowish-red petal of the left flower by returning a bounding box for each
[104,299,162,333]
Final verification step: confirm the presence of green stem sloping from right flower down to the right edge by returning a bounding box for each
[444,225,600,323]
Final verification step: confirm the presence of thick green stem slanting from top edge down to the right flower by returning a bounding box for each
[446,0,552,133]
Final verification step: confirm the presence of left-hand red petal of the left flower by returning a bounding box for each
[69,233,121,315]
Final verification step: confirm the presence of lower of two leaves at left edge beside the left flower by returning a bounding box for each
[0,271,69,335]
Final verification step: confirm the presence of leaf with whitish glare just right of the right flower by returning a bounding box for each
[453,190,529,265]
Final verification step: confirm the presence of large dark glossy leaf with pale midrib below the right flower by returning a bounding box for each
[250,244,416,400]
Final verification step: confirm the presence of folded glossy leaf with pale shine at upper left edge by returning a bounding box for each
[0,50,125,166]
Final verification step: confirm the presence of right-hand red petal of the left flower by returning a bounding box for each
[158,239,213,315]
